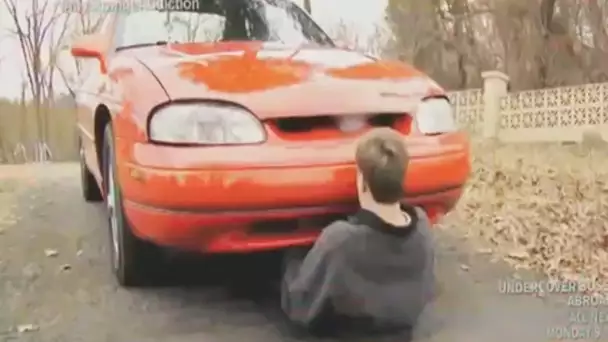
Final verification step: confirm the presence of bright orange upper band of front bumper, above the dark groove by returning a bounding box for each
[118,144,470,211]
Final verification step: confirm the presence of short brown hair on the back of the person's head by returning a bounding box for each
[355,128,409,204]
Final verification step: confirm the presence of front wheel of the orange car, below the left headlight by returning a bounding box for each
[103,124,162,287]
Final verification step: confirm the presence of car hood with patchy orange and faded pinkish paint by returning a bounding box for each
[128,42,444,119]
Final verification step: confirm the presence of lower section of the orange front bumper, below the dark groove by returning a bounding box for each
[124,188,462,253]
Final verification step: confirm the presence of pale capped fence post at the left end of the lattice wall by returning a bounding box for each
[481,70,509,139]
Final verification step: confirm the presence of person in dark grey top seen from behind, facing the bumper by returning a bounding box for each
[281,129,434,341]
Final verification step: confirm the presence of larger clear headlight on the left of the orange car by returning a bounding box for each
[148,103,266,145]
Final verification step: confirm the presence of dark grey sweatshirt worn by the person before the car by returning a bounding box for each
[281,207,435,334]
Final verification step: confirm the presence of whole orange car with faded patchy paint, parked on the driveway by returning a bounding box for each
[71,0,469,286]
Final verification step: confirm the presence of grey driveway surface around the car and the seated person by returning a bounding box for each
[0,164,608,342]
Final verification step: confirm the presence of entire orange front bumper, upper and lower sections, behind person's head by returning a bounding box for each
[116,135,470,252]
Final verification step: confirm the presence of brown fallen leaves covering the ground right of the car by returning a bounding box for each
[444,144,608,292]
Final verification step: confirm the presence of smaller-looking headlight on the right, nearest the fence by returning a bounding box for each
[415,98,458,134]
